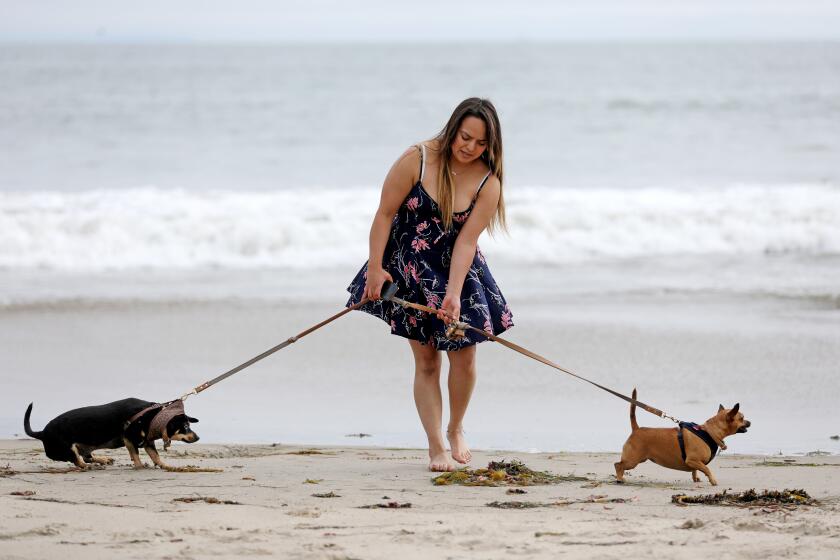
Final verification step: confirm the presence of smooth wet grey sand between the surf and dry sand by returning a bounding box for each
[0,296,840,454]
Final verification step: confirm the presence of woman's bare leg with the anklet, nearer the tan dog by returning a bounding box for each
[446,345,476,464]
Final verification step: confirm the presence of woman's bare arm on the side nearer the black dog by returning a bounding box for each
[365,148,420,300]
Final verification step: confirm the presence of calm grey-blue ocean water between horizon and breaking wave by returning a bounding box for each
[0,43,840,192]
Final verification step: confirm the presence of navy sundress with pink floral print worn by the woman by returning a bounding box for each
[347,145,513,351]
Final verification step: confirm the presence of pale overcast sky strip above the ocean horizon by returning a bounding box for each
[0,0,840,43]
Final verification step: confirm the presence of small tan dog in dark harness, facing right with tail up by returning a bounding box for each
[615,389,750,486]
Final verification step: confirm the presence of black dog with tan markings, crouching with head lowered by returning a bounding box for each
[23,399,198,470]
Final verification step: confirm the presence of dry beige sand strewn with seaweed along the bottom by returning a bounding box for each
[0,440,840,559]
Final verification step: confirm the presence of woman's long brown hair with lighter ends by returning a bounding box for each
[432,97,507,234]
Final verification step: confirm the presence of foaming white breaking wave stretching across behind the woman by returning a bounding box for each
[0,185,840,272]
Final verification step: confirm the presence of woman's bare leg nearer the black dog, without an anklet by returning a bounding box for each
[408,340,454,471]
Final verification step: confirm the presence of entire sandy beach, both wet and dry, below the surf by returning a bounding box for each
[0,274,840,559]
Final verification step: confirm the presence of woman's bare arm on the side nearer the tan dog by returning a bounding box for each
[438,176,502,321]
